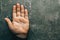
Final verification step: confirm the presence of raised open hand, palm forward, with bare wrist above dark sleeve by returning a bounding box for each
[5,3,29,38]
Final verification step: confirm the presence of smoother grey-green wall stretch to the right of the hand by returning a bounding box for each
[28,0,60,40]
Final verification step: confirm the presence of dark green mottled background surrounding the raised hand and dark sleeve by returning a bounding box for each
[0,0,60,40]
